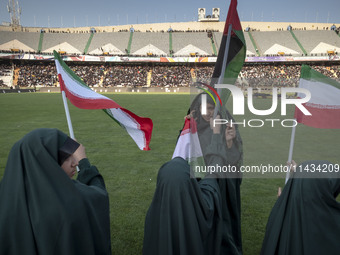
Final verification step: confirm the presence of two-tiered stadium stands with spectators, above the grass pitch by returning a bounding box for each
[0,11,340,92]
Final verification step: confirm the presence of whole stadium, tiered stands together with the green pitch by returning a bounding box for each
[0,1,340,255]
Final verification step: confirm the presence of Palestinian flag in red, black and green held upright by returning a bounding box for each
[211,0,246,104]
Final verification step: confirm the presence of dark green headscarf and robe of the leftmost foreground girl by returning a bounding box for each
[0,129,110,255]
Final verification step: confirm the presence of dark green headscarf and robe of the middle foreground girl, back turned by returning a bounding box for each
[143,157,225,255]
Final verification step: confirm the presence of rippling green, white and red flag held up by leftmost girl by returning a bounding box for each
[54,51,153,150]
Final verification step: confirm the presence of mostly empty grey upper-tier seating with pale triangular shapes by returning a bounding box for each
[0,30,340,56]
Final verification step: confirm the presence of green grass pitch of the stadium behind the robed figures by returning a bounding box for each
[0,93,340,255]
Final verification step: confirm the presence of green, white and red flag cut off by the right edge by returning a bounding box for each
[295,65,340,129]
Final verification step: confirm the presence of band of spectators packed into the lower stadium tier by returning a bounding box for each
[0,62,340,87]
